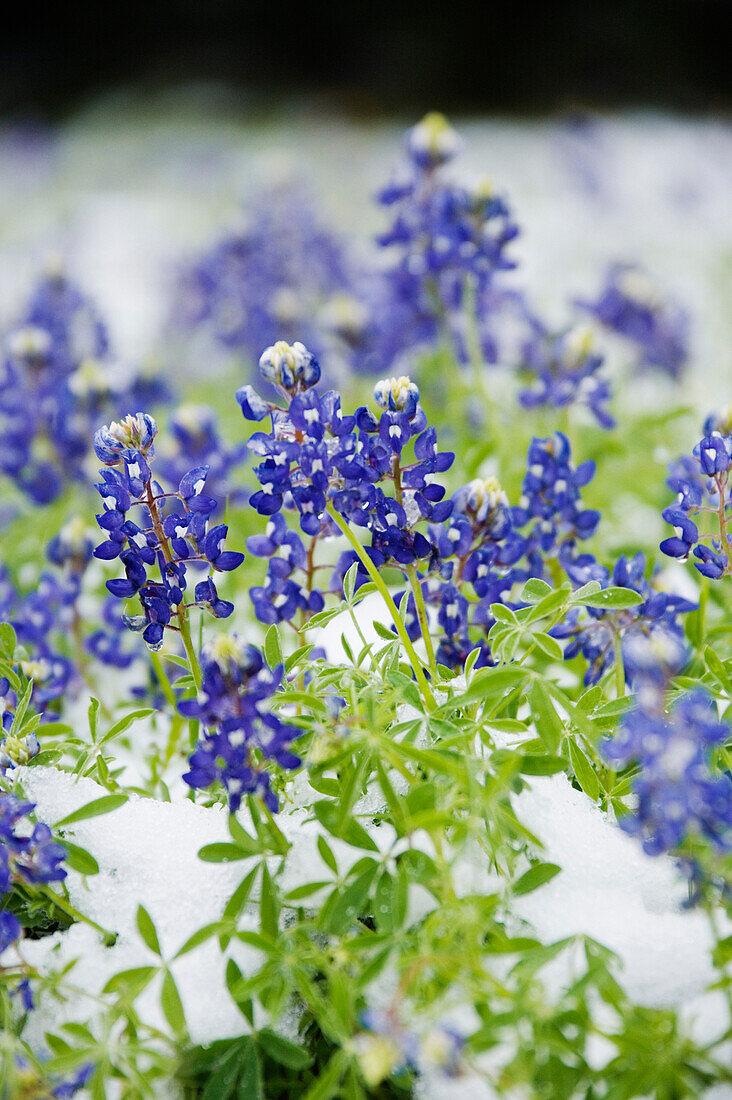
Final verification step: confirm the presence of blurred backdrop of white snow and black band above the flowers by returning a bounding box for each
[0,0,732,407]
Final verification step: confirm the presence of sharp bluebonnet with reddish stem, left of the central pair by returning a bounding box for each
[94,413,244,651]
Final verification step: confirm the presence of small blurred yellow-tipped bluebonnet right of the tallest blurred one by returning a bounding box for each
[518,322,615,428]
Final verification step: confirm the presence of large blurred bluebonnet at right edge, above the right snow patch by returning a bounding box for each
[602,634,732,856]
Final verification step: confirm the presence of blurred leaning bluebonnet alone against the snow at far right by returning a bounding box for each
[578,264,689,378]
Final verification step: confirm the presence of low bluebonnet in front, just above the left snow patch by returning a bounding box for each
[178,635,301,813]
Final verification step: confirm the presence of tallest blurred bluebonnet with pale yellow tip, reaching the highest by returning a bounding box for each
[375,114,518,367]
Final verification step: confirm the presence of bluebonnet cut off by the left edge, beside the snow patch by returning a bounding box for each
[0,791,66,955]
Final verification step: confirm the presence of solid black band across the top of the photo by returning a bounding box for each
[0,0,732,120]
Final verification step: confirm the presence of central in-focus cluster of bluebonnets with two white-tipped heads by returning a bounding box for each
[237,341,454,623]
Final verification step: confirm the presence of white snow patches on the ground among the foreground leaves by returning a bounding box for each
[21,767,725,1073]
